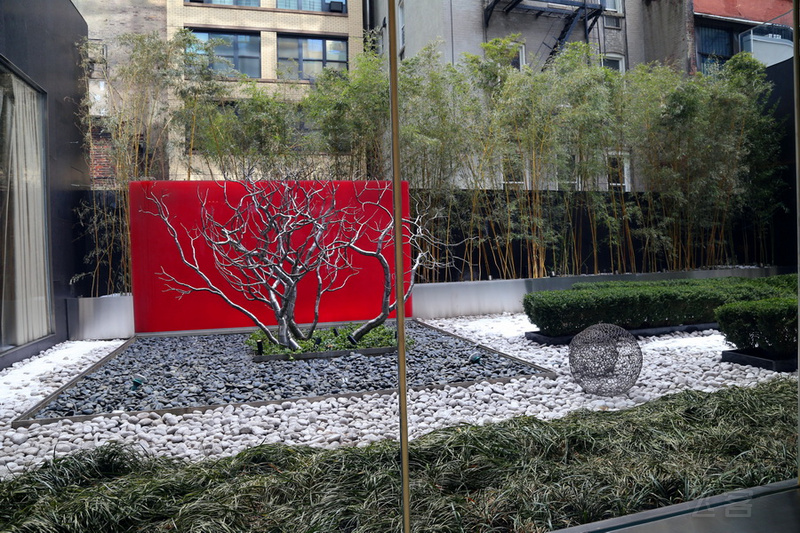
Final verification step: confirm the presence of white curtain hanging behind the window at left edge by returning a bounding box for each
[0,71,52,349]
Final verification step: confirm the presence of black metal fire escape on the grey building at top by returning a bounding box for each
[483,0,605,63]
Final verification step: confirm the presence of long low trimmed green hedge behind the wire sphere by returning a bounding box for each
[523,275,797,337]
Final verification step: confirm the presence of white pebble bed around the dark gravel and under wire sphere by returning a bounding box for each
[0,314,797,478]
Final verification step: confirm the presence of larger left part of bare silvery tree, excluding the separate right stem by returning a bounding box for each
[143,181,357,350]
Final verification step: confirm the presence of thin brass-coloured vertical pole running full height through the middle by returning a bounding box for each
[387,0,411,533]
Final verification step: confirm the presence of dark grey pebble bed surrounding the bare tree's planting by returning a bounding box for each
[34,322,537,418]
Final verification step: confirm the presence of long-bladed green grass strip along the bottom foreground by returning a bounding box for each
[0,379,797,533]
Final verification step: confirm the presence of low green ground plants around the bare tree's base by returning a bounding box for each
[245,324,397,355]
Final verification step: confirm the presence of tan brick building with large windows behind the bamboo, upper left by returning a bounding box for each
[73,0,364,183]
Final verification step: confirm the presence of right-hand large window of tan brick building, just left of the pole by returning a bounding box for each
[278,36,347,80]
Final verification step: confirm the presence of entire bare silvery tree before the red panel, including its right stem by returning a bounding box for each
[141,181,440,350]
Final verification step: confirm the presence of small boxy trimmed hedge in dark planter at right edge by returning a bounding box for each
[715,298,797,357]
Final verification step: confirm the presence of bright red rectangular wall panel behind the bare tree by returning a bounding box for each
[130,181,411,333]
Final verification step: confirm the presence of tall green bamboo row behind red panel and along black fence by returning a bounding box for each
[83,35,786,288]
